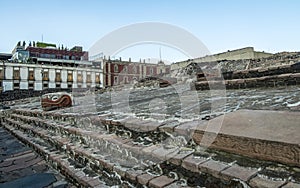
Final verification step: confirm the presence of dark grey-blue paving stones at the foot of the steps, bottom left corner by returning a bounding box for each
[0,127,70,188]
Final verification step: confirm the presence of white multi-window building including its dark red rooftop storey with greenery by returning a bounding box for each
[0,43,103,92]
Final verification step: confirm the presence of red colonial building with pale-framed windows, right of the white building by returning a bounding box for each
[104,59,170,87]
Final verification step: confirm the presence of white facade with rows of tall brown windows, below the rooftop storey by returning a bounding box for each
[0,61,103,92]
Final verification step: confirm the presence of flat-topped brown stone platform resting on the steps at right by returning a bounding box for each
[193,110,300,166]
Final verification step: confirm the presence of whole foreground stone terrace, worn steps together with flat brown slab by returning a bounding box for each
[1,108,300,188]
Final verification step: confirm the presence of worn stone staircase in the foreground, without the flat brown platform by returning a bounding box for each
[1,109,300,188]
